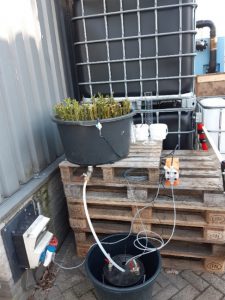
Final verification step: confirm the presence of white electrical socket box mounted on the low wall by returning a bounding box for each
[12,215,53,269]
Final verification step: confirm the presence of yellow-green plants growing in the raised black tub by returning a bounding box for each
[54,95,131,121]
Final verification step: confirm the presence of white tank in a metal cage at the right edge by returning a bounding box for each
[200,97,225,153]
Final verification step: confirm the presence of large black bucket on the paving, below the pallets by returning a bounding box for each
[85,234,161,300]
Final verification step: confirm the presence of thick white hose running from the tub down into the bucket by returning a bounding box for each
[83,177,125,272]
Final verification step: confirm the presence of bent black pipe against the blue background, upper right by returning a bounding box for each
[196,20,217,73]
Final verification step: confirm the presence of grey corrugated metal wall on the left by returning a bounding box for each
[0,0,73,200]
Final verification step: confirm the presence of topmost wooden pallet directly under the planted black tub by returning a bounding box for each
[59,141,162,186]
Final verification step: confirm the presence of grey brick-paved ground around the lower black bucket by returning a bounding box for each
[27,233,225,300]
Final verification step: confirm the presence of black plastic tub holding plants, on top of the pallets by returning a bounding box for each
[53,113,133,166]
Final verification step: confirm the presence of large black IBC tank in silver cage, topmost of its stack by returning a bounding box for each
[72,0,196,97]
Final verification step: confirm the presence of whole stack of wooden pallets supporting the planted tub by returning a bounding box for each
[60,142,225,273]
